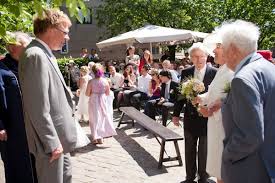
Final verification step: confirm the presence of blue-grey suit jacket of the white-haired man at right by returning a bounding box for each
[222,54,275,183]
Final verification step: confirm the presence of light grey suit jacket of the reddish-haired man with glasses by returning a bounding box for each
[19,40,76,154]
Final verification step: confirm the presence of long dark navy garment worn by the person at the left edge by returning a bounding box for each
[0,59,33,182]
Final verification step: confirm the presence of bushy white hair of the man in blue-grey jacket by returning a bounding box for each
[217,20,260,53]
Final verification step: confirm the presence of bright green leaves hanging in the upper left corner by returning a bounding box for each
[0,0,87,53]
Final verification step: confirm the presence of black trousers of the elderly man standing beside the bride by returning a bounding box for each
[184,130,209,181]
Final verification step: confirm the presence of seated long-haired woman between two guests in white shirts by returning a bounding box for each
[117,64,136,108]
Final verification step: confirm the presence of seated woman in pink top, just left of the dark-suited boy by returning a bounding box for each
[149,69,161,100]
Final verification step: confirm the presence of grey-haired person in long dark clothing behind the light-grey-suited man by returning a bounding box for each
[0,32,37,183]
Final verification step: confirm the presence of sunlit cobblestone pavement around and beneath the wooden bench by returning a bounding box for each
[0,109,219,183]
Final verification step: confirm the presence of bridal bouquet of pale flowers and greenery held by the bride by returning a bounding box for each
[179,78,205,102]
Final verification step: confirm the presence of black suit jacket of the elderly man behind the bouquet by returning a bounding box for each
[173,66,217,136]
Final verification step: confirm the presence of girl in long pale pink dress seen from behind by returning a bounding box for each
[86,64,116,144]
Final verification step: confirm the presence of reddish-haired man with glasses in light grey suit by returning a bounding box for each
[19,9,76,183]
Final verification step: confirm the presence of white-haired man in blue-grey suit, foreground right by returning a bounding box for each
[218,20,275,183]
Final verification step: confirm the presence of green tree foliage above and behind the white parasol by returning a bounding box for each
[97,0,275,49]
